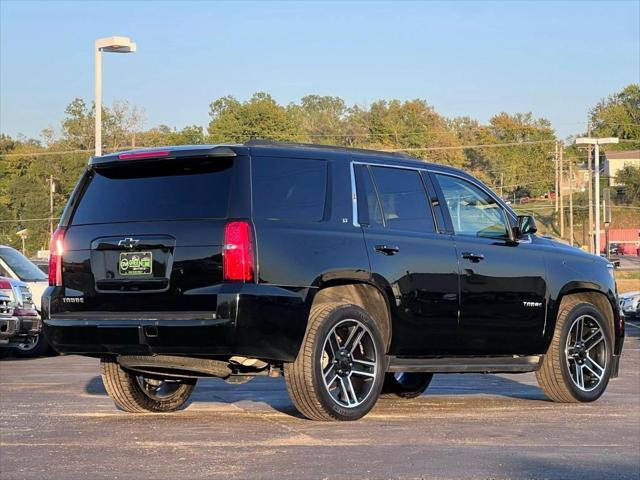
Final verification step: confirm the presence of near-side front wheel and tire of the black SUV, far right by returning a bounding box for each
[536,297,613,403]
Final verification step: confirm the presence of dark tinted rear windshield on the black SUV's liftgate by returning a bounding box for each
[71,158,233,225]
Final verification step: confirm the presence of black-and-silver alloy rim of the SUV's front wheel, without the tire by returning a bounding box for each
[564,315,608,392]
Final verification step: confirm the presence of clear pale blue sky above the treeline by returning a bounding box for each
[0,0,640,138]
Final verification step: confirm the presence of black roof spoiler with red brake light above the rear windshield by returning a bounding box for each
[89,145,237,166]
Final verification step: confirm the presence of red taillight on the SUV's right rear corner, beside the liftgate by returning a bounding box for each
[222,221,255,282]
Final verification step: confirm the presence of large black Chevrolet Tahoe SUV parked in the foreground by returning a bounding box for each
[43,141,624,420]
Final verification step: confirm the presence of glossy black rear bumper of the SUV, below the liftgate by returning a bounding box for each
[43,284,308,362]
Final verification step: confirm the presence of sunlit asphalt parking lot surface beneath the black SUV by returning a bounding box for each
[0,322,640,480]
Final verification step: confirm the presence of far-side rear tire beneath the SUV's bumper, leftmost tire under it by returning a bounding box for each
[100,357,196,413]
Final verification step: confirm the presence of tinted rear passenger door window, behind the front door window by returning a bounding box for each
[371,167,435,232]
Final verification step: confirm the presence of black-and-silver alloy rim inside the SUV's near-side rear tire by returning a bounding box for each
[320,319,378,408]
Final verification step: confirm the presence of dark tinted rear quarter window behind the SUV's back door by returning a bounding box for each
[251,157,327,221]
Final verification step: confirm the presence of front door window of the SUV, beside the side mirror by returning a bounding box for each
[435,174,509,238]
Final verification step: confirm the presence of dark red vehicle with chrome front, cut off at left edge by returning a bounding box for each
[0,277,41,357]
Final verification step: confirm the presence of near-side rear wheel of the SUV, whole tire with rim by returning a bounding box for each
[284,303,385,421]
